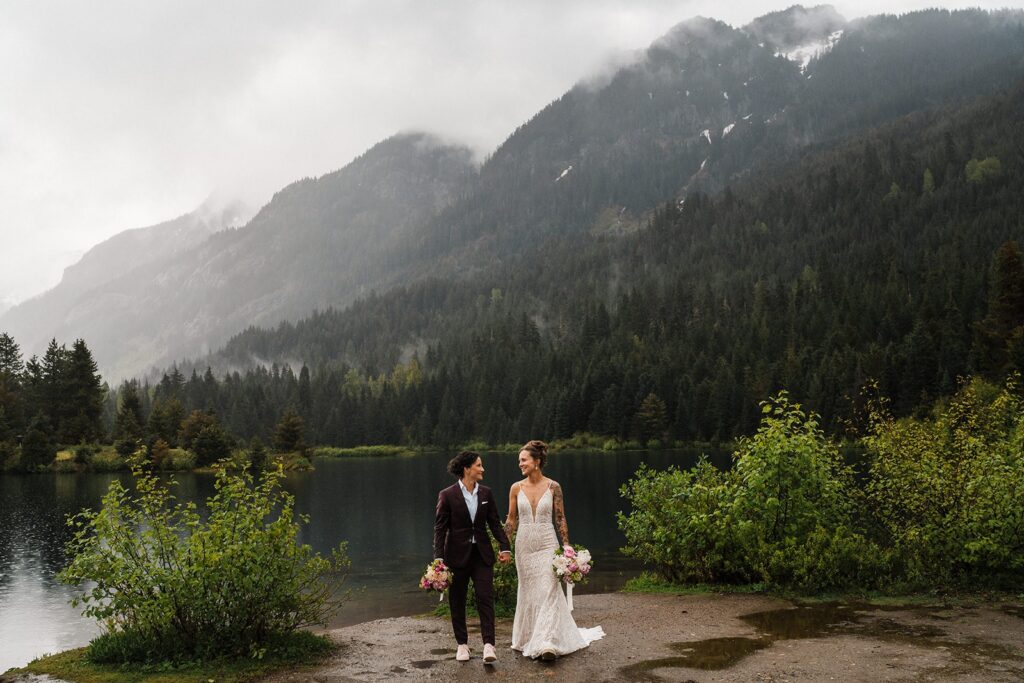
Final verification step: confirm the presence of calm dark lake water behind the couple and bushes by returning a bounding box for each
[0,451,728,672]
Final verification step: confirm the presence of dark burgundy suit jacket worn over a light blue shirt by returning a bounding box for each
[434,481,510,569]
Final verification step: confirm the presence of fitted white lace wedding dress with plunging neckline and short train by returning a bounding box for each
[512,486,604,657]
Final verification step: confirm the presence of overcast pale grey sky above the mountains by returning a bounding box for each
[0,0,1024,309]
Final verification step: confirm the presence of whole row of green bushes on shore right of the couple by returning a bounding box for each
[618,377,1024,593]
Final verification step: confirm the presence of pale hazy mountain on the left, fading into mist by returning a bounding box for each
[0,134,475,379]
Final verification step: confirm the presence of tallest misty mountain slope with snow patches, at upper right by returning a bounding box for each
[409,8,1024,268]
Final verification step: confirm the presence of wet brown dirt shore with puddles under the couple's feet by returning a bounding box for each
[269,593,1024,683]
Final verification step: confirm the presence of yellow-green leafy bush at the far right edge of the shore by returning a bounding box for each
[864,380,1024,585]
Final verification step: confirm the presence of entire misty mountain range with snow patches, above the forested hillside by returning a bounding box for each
[0,6,1024,378]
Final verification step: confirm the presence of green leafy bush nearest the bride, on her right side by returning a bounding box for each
[618,392,886,590]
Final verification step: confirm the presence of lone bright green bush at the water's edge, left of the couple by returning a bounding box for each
[59,455,348,661]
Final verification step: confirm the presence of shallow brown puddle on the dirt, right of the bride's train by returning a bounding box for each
[620,602,1024,681]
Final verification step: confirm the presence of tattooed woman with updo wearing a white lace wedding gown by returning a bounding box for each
[505,440,604,659]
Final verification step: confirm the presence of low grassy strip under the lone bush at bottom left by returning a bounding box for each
[8,632,338,683]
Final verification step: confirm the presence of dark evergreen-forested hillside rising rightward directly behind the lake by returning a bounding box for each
[142,74,1024,444]
